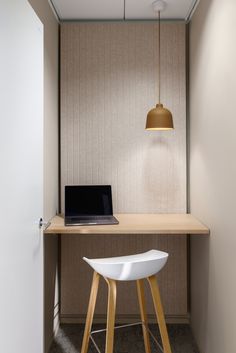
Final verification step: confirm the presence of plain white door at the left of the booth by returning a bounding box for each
[0,0,44,353]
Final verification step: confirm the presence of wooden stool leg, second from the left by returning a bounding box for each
[105,278,116,353]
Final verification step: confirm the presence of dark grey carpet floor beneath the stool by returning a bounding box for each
[49,324,199,353]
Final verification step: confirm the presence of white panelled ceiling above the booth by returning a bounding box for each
[49,0,199,20]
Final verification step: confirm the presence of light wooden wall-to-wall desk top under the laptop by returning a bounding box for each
[44,213,210,235]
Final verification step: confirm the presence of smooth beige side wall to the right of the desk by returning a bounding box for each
[190,0,236,353]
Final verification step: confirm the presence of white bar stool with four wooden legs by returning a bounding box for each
[81,250,171,353]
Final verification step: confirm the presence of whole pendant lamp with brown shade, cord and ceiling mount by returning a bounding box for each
[146,0,174,130]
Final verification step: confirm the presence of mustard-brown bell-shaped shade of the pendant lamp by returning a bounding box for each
[146,103,174,130]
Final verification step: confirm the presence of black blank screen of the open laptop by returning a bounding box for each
[65,185,113,217]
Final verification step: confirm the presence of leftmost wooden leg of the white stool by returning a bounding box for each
[81,271,100,353]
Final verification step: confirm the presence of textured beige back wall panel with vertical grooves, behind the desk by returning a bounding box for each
[61,22,187,316]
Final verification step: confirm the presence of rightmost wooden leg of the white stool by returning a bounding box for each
[148,276,171,353]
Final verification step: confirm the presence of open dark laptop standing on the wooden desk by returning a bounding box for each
[65,185,119,226]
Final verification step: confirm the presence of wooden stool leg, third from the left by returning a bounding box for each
[137,279,151,353]
